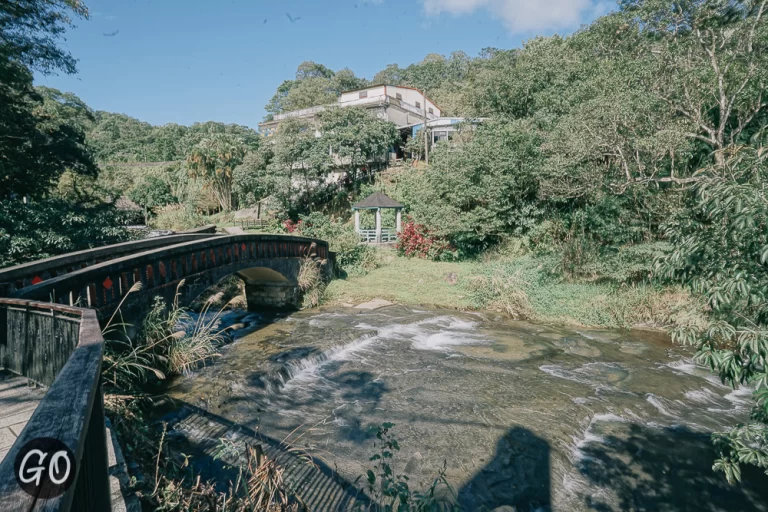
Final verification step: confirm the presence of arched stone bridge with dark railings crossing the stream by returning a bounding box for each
[0,234,333,319]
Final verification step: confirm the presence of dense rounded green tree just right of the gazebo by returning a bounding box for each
[396,121,542,255]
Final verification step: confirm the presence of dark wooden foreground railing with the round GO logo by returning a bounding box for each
[0,299,111,511]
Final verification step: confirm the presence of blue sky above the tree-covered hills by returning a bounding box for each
[35,0,615,128]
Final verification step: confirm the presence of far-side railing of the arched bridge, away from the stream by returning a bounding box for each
[0,231,216,297]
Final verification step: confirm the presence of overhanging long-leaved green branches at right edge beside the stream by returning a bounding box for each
[658,148,768,481]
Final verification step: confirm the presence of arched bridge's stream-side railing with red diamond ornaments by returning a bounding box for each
[15,235,331,317]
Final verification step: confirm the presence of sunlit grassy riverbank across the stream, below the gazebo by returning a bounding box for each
[324,248,705,329]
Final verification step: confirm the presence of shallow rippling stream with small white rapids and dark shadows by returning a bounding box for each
[170,306,768,511]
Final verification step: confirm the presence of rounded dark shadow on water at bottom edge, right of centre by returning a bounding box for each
[458,427,551,511]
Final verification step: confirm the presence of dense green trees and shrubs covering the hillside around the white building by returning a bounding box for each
[0,0,768,488]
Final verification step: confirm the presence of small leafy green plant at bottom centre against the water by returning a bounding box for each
[357,423,460,512]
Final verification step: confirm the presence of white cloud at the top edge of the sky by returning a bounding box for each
[422,0,610,33]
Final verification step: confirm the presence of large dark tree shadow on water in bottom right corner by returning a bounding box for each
[579,424,768,511]
